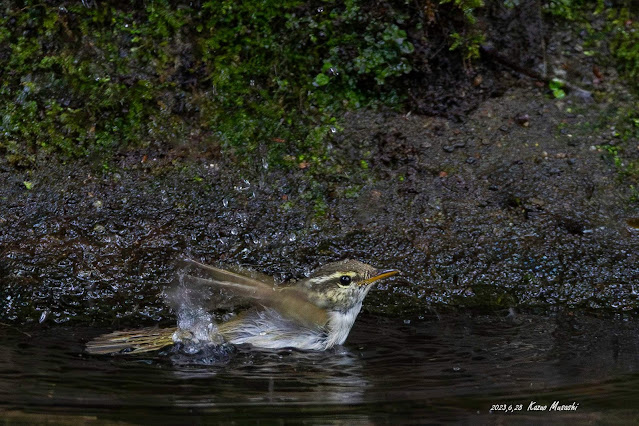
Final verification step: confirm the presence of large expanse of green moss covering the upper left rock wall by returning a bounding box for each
[0,0,428,170]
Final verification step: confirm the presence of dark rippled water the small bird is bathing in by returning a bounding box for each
[0,314,639,424]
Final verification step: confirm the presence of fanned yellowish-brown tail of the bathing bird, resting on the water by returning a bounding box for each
[87,327,177,355]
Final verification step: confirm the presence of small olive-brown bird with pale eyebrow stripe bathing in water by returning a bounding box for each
[87,260,399,354]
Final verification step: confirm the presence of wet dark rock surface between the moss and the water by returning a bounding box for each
[0,83,639,326]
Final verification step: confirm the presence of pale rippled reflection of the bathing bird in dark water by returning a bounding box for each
[170,345,369,407]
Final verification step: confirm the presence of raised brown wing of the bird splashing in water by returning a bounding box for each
[182,259,328,328]
